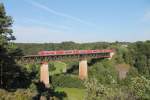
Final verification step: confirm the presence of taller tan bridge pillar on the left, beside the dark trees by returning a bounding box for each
[40,62,49,87]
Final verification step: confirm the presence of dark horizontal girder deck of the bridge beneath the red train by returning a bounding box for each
[19,50,112,62]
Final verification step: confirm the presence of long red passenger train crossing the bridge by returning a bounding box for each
[38,49,113,56]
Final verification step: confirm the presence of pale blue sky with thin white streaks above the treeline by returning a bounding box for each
[0,0,150,43]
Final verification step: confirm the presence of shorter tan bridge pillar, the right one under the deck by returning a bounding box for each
[79,60,88,80]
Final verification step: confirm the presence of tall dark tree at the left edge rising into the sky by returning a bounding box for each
[0,3,27,88]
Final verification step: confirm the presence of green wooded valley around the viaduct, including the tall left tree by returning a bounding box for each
[0,4,150,100]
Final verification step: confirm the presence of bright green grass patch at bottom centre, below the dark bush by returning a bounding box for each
[56,87,85,100]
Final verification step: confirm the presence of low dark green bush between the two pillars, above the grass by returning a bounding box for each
[52,75,84,88]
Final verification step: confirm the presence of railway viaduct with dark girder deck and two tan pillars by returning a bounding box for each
[21,49,114,87]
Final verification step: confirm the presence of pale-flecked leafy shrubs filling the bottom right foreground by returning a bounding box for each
[85,77,150,100]
